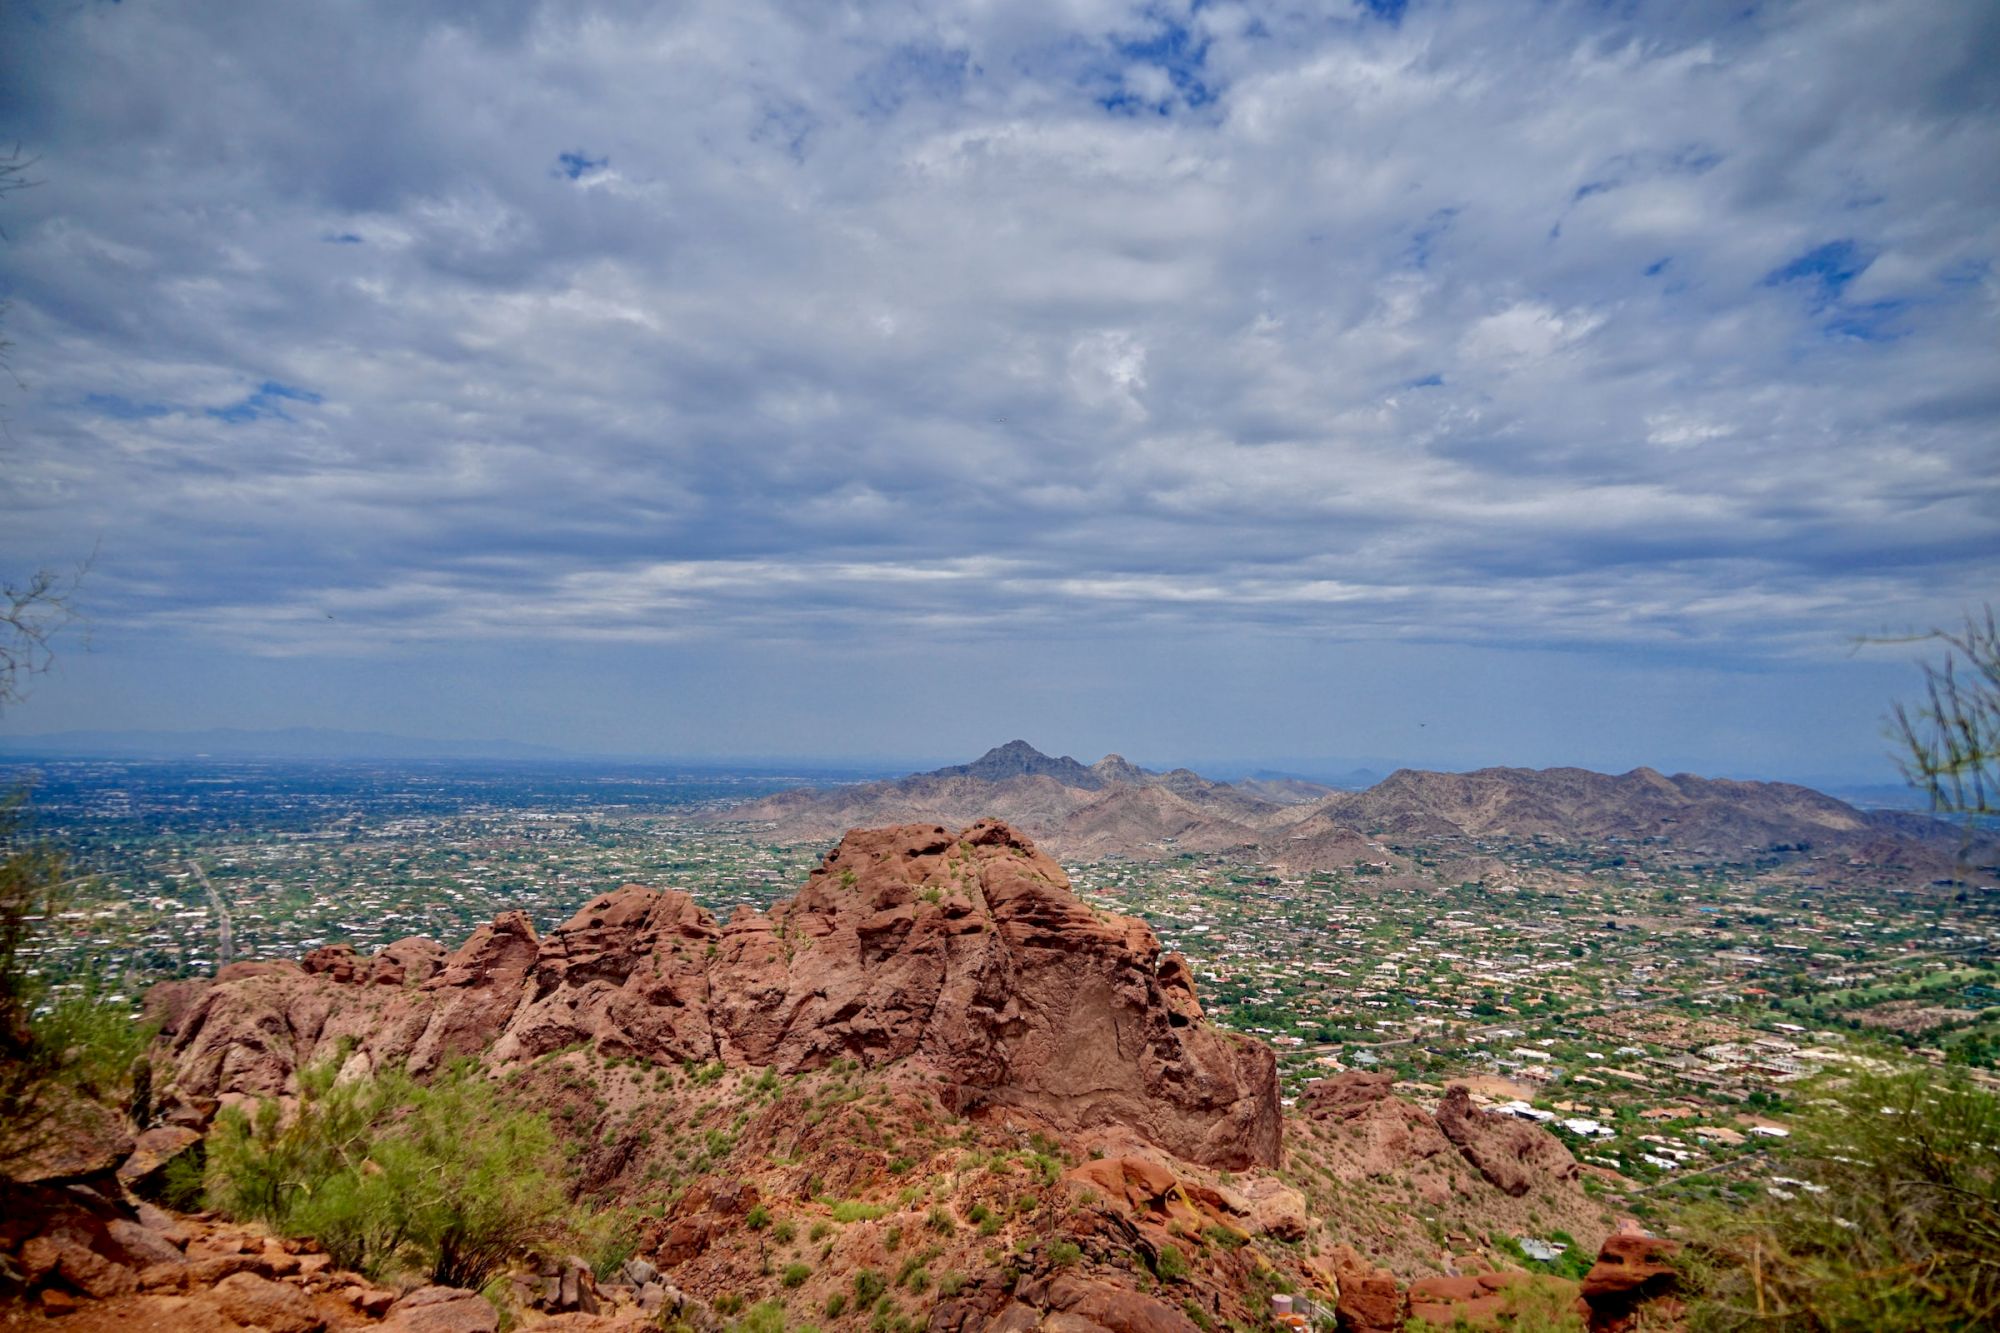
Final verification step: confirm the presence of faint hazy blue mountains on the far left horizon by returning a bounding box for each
[0,727,570,759]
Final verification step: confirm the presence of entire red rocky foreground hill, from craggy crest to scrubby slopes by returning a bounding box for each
[0,821,1672,1333]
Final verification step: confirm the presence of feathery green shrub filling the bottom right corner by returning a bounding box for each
[1680,1071,2000,1333]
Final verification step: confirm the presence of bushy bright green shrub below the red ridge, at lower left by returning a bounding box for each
[208,1061,564,1291]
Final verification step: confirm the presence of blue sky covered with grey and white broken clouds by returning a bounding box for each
[0,0,2000,777]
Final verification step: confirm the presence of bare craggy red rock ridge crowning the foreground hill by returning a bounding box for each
[166,821,1280,1167]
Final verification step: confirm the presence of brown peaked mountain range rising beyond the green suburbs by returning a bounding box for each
[724,741,1984,873]
